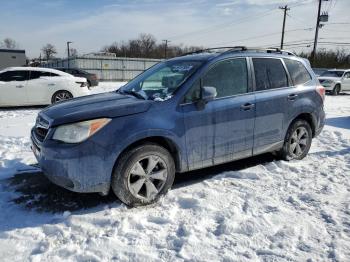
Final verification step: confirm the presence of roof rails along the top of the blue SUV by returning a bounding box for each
[182,46,295,56]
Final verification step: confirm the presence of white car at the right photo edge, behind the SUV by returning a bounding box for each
[318,69,350,95]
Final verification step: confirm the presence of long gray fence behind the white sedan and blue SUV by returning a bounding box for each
[42,56,161,81]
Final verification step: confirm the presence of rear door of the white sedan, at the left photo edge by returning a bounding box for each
[0,70,29,106]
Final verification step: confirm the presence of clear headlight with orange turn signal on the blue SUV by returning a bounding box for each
[52,118,111,143]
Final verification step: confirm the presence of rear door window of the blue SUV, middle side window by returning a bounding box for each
[253,58,288,91]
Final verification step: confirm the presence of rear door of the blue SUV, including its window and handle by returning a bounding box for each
[252,57,298,154]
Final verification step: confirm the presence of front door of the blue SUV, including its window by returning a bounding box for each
[183,58,255,169]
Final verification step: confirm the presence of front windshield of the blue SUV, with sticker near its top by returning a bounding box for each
[118,61,202,101]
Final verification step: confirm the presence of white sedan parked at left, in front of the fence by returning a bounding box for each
[0,67,90,106]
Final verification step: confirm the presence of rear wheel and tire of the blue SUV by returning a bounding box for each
[279,119,312,161]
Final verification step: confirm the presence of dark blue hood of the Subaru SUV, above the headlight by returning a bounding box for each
[39,91,153,126]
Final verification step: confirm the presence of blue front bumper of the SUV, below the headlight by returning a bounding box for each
[31,129,113,194]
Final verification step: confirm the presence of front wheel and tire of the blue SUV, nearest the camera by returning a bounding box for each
[111,144,175,206]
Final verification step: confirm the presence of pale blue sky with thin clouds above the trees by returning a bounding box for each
[0,0,350,57]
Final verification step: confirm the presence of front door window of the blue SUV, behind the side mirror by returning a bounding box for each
[203,58,248,97]
